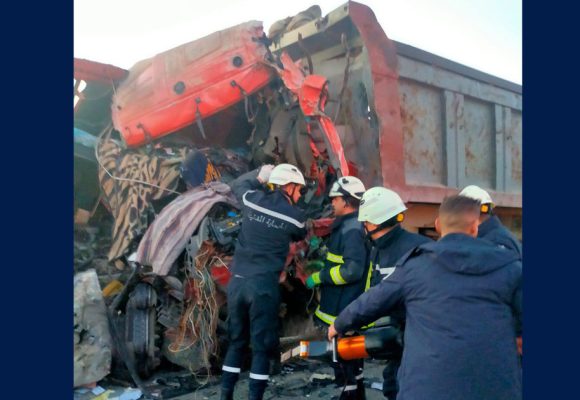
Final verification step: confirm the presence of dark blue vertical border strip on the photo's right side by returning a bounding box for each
[523,2,580,400]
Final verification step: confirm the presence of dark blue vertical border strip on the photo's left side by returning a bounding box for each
[0,2,73,399]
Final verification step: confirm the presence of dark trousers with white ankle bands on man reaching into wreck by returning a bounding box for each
[223,273,280,381]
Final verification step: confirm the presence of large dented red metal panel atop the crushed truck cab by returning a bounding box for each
[112,21,274,147]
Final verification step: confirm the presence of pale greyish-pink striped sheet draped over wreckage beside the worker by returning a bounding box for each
[136,182,238,276]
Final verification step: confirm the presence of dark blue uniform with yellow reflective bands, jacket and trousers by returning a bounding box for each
[314,212,368,399]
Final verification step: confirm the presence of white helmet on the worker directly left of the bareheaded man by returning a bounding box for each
[358,186,407,225]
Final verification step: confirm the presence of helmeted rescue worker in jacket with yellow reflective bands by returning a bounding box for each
[306,176,367,399]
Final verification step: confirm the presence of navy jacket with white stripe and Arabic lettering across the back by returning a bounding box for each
[231,170,306,277]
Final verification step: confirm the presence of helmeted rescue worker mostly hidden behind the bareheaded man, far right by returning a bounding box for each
[459,185,522,260]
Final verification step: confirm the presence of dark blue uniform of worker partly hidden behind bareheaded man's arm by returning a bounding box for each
[369,225,431,400]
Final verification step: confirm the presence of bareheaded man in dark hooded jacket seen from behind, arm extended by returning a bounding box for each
[329,196,522,400]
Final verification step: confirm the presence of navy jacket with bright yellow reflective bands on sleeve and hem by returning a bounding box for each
[314,212,368,325]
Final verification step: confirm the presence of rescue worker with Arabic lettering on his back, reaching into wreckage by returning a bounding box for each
[221,164,306,400]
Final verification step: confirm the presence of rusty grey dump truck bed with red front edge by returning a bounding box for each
[271,2,522,209]
